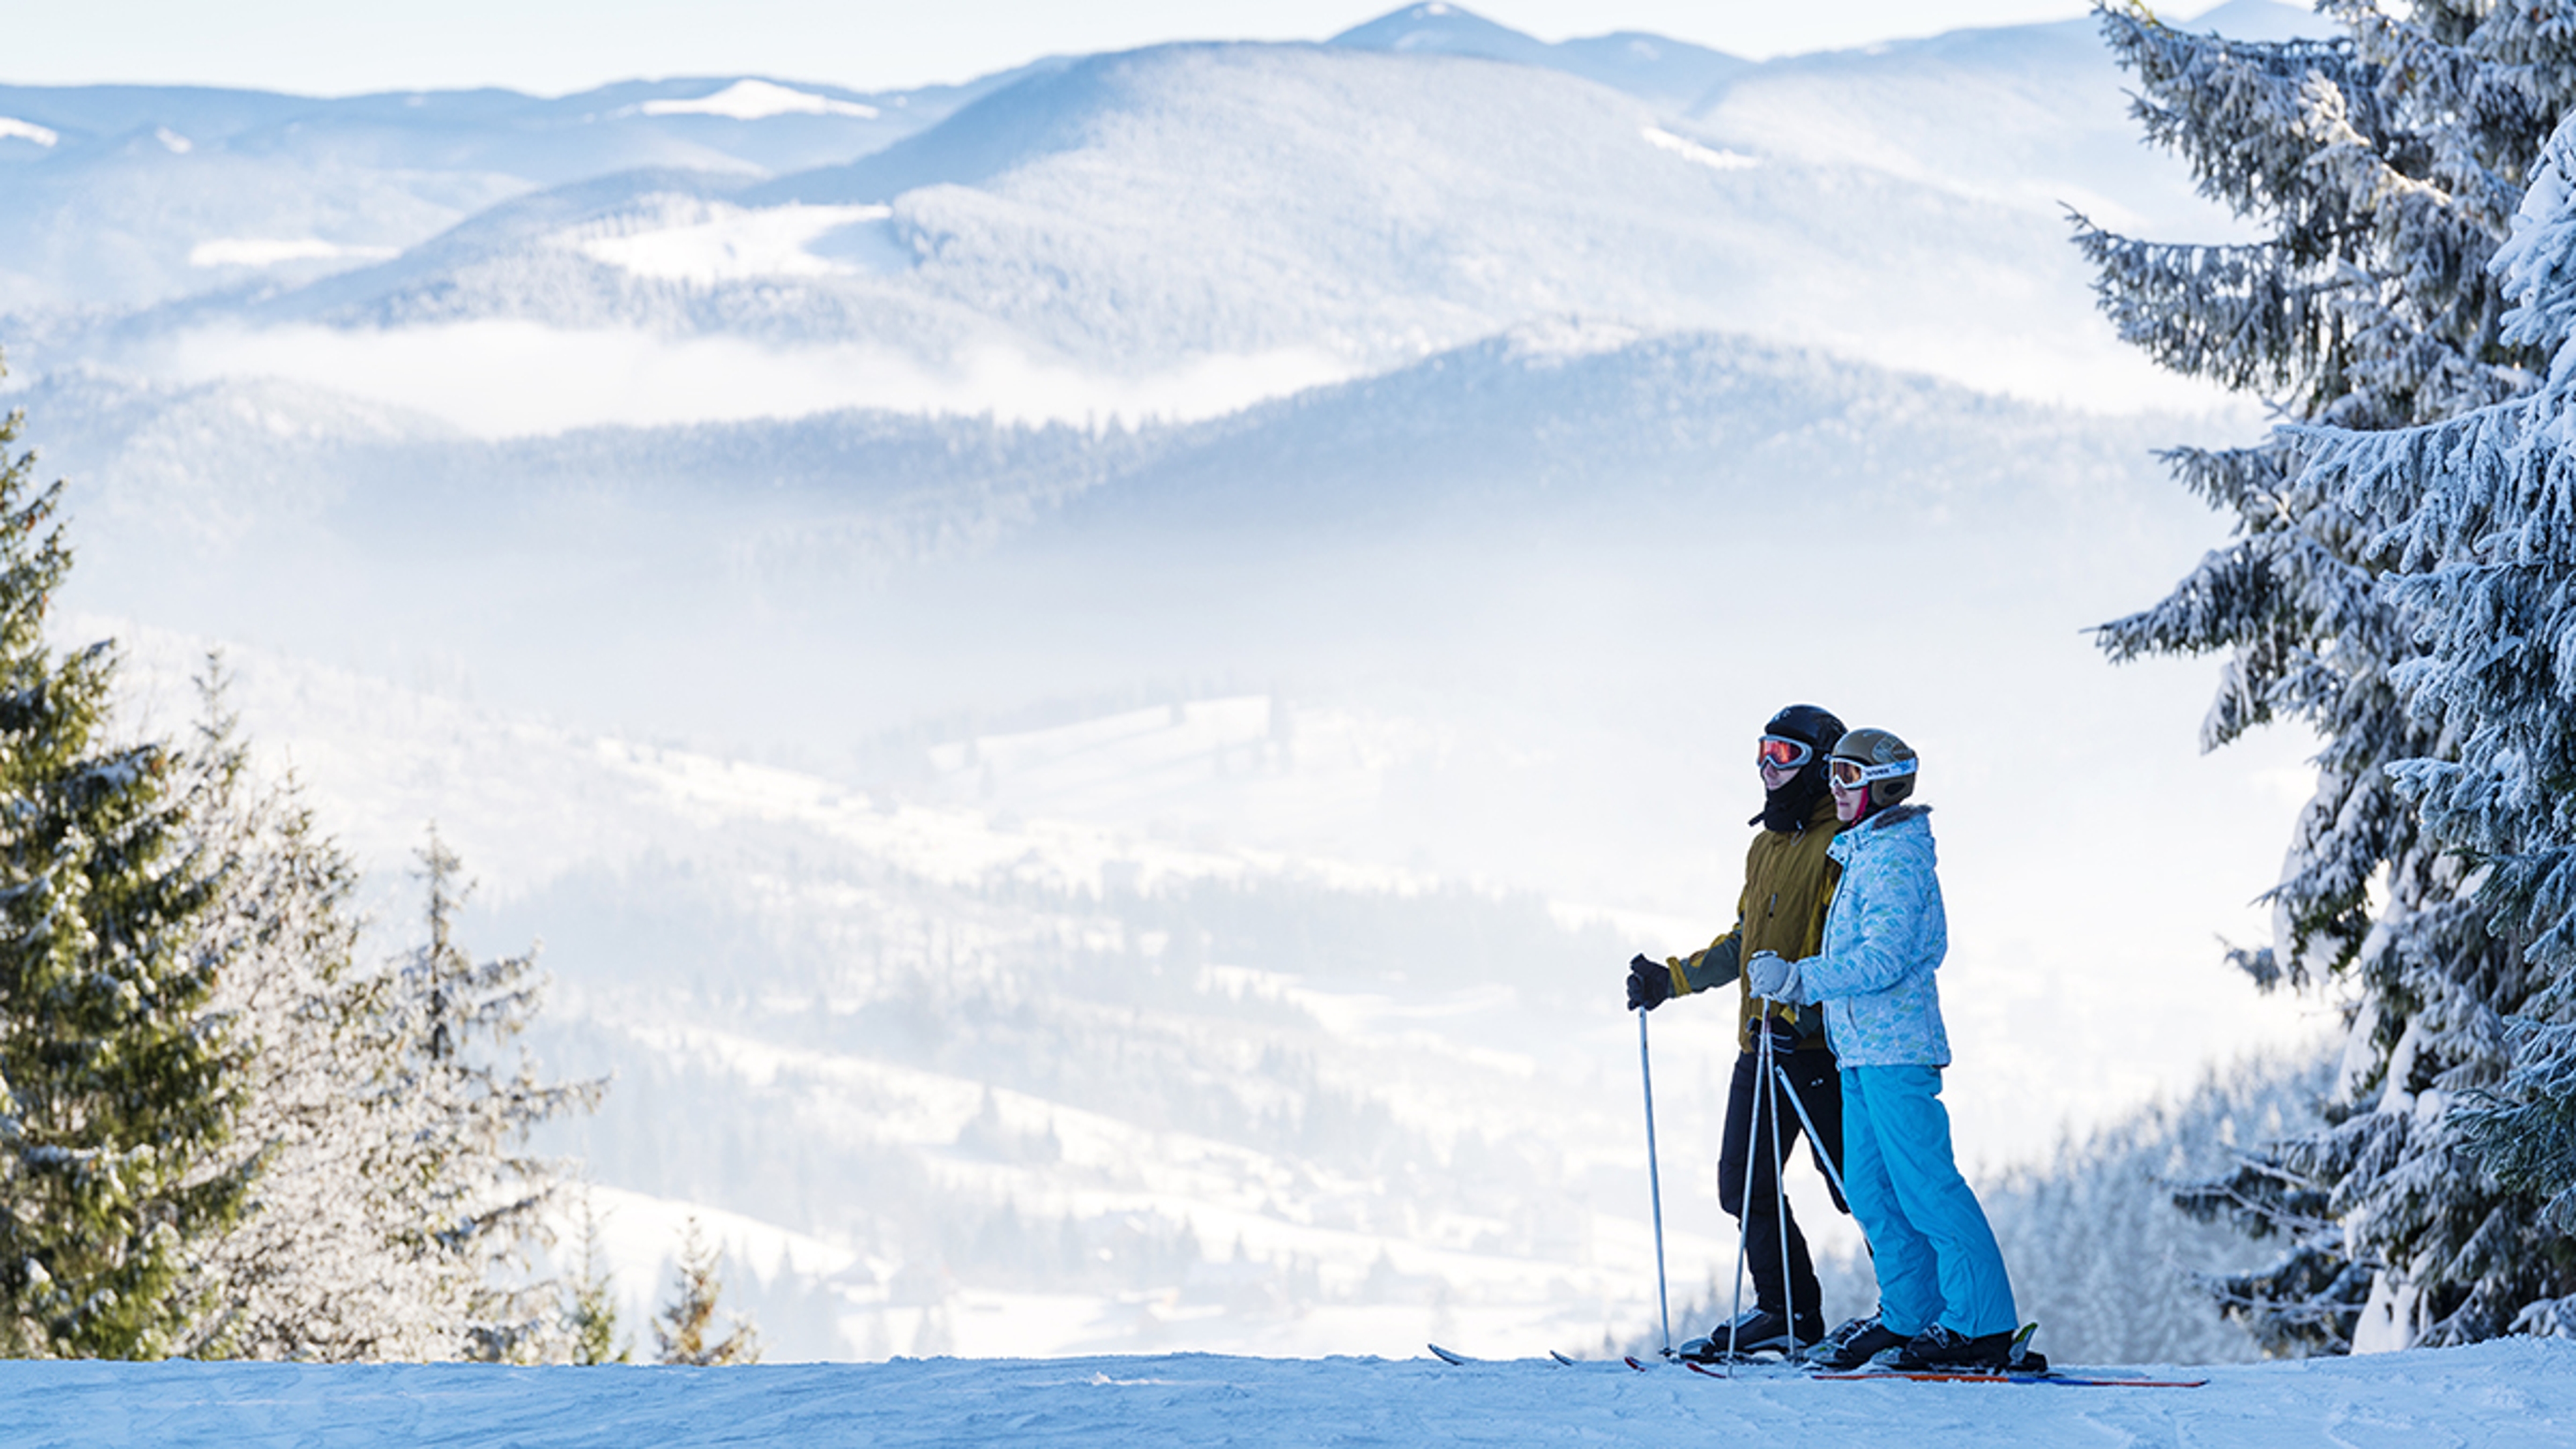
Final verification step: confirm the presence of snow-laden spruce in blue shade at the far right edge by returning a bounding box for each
[2290,116,2576,1336]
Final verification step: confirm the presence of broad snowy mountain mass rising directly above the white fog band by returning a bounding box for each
[20,10,2328,433]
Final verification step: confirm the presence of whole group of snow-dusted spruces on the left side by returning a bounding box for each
[0,366,757,1364]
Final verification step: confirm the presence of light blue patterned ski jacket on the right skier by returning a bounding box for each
[1798,804,1950,1067]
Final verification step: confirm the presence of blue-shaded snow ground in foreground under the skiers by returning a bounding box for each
[0,1338,2576,1449]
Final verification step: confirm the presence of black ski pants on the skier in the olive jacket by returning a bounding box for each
[1718,1049,1852,1323]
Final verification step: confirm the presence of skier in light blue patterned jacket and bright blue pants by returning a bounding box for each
[1744,730,2015,1369]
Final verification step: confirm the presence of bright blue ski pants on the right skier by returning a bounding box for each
[1842,1067,2020,1338]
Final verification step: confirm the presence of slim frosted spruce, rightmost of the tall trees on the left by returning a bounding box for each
[384,828,608,1361]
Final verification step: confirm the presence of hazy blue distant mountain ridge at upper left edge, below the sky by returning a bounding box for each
[0,72,1056,309]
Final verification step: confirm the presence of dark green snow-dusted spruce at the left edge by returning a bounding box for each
[0,374,248,1358]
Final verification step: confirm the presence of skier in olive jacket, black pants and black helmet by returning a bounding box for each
[1628,704,1842,1361]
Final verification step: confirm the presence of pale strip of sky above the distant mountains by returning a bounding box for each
[20,0,2102,95]
